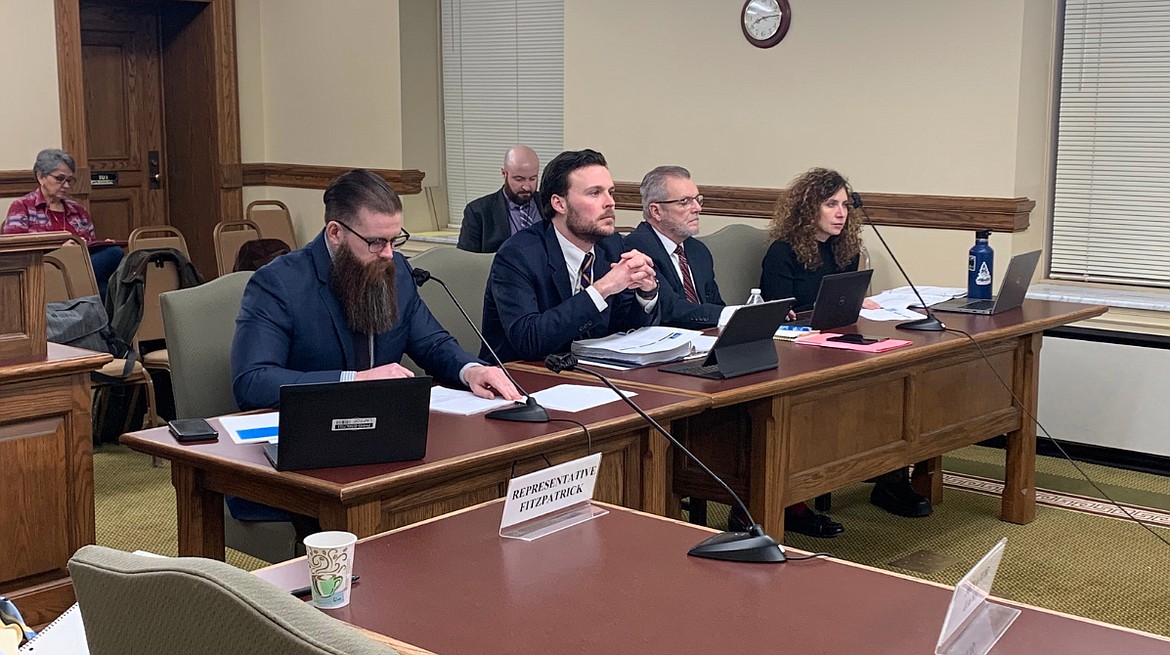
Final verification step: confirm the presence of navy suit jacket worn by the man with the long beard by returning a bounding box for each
[232,233,479,409]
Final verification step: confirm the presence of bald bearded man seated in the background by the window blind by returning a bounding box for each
[459,145,541,253]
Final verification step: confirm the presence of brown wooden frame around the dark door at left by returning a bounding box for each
[54,0,243,223]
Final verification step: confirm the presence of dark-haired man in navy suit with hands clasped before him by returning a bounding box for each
[481,150,659,361]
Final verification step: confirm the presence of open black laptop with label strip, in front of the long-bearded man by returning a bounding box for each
[264,375,431,471]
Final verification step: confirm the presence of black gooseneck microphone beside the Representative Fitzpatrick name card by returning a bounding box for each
[544,352,787,563]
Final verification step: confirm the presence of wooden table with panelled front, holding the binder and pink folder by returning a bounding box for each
[516,301,1106,538]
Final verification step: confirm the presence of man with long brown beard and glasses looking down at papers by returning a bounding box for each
[232,170,519,409]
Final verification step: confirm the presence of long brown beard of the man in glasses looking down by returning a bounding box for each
[329,246,398,335]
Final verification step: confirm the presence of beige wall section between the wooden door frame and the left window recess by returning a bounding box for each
[236,0,402,240]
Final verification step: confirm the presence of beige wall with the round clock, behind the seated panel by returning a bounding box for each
[565,0,1055,288]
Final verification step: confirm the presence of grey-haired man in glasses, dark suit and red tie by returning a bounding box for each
[624,166,724,330]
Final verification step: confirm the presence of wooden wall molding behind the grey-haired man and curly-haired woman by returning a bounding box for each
[614,182,1035,232]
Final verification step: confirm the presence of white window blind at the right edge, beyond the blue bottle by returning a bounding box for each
[1051,0,1170,288]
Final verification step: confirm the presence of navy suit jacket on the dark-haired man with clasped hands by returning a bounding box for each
[480,221,658,361]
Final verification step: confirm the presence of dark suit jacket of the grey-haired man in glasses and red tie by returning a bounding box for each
[622,221,727,330]
